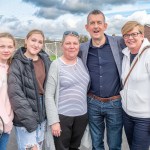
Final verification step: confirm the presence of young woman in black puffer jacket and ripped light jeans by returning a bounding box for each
[8,30,50,150]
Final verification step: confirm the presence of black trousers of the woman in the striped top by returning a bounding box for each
[54,114,88,150]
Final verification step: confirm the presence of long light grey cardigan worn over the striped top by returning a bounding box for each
[45,59,91,150]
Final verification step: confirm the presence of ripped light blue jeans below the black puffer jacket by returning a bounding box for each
[15,121,46,150]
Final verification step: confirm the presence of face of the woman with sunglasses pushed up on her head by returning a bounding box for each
[62,35,79,60]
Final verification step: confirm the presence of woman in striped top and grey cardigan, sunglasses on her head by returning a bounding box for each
[45,31,89,150]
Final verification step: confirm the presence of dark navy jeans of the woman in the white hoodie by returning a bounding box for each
[123,112,150,150]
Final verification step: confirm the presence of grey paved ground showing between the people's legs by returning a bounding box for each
[7,127,129,150]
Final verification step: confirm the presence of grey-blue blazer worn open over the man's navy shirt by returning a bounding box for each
[79,35,126,77]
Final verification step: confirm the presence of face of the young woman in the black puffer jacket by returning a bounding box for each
[25,33,44,58]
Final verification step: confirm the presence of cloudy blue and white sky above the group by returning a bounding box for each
[0,0,150,40]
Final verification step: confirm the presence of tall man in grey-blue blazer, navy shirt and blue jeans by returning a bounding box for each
[79,10,125,150]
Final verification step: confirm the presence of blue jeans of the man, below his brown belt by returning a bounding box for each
[88,97,123,150]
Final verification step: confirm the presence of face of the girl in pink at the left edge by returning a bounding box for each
[0,37,15,63]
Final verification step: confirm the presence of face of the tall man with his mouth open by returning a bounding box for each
[85,14,107,40]
